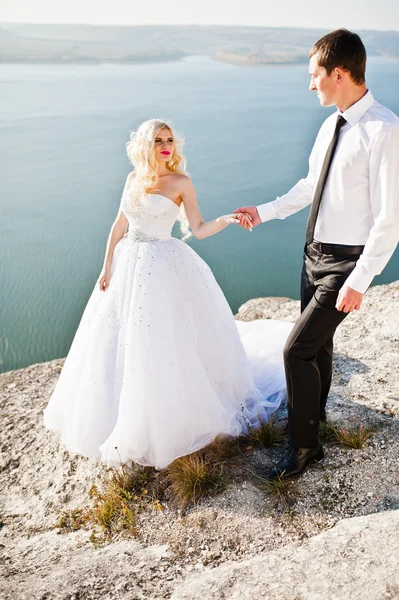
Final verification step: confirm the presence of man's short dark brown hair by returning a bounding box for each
[309,29,367,85]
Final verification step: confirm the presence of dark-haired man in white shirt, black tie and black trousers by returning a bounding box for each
[235,29,399,479]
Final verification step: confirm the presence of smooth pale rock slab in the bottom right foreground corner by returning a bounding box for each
[171,511,399,600]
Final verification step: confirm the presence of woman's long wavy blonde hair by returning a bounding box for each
[126,119,191,241]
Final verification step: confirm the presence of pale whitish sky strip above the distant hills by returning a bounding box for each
[0,0,399,31]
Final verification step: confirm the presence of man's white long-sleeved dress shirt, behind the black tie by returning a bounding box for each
[257,91,399,294]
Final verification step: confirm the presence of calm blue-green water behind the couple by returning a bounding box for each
[0,58,399,371]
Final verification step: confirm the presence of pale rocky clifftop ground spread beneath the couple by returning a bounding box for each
[0,282,399,600]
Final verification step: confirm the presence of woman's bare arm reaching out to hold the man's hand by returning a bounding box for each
[181,177,249,240]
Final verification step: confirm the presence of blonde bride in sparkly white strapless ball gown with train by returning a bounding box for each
[44,119,292,469]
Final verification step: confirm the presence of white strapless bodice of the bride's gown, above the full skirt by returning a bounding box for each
[121,191,180,242]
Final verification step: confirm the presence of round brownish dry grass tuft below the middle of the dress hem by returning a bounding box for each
[168,453,226,506]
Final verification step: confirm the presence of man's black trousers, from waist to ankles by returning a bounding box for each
[284,242,361,448]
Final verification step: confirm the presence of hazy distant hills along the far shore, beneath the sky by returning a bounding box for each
[0,23,399,66]
